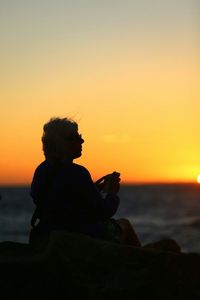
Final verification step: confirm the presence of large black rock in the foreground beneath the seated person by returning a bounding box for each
[0,232,200,300]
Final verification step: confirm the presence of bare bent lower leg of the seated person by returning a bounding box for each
[116,218,141,247]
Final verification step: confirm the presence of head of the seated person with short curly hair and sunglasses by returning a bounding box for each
[42,118,84,162]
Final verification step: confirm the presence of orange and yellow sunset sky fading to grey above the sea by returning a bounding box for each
[0,0,200,185]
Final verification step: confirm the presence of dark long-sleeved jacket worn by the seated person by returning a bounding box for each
[31,161,119,236]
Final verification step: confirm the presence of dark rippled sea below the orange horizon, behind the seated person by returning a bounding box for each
[0,184,200,253]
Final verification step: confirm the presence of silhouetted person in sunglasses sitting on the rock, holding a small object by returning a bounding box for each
[30,118,140,246]
